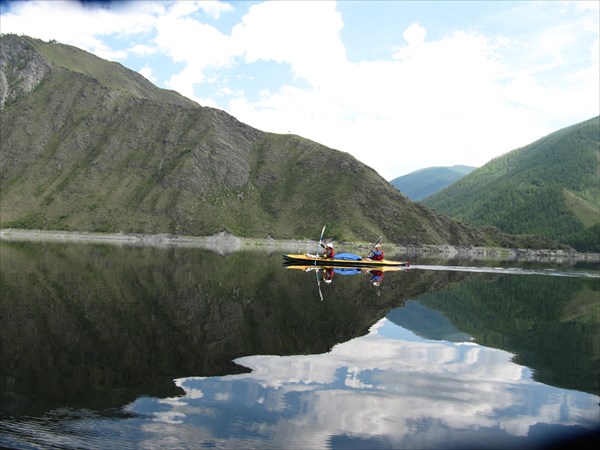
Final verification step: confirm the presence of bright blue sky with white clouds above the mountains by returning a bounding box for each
[0,0,600,180]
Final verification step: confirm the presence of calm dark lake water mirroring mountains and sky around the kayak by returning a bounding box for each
[0,242,600,449]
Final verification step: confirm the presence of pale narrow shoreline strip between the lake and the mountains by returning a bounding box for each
[0,228,600,262]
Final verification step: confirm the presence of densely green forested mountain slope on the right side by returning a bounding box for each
[423,117,600,252]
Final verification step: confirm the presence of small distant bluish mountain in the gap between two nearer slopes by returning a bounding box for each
[390,166,475,201]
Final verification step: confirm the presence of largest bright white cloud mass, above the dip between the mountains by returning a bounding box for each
[228,5,598,178]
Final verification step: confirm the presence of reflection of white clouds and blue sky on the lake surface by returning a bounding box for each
[127,319,600,449]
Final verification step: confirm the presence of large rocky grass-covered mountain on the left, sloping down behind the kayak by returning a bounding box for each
[0,35,564,247]
